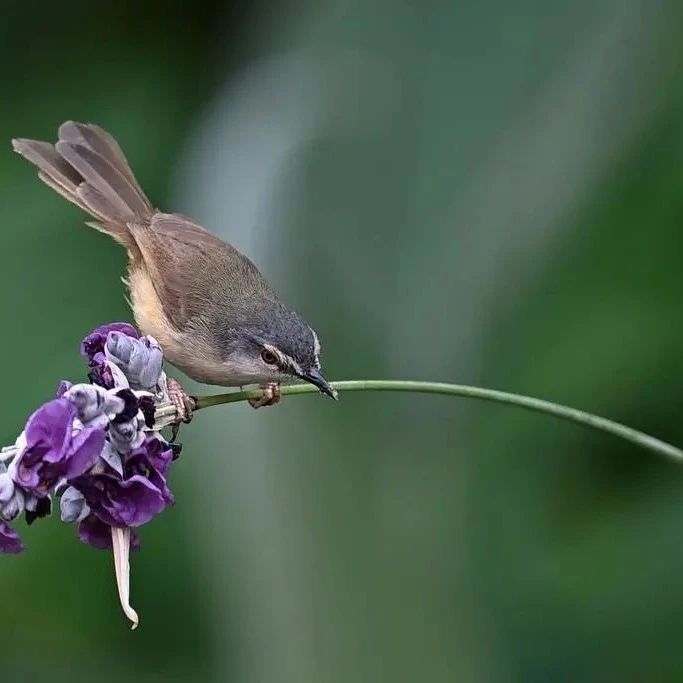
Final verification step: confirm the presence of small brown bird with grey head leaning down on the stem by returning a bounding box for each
[12,121,336,421]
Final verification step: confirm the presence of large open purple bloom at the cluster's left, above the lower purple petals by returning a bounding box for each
[13,398,105,497]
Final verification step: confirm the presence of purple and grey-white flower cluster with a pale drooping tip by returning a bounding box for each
[0,323,178,623]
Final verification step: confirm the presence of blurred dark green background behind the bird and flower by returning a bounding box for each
[0,0,683,683]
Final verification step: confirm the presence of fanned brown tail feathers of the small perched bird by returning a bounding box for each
[12,121,154,248]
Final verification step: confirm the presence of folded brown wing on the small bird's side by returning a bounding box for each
[129,213,267,330]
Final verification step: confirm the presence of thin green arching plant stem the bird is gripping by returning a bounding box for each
[194,380,683,461]
